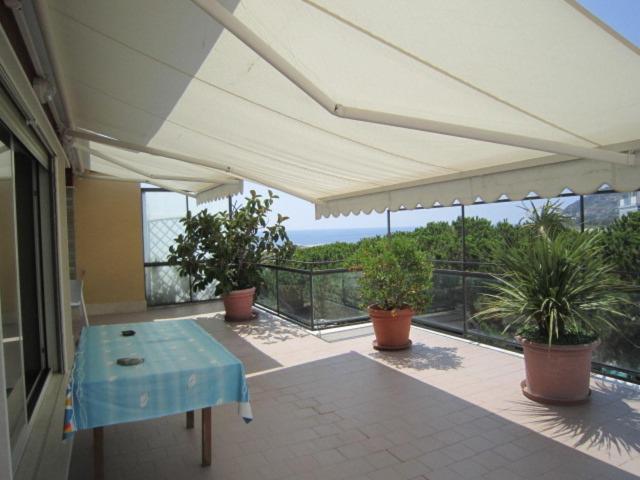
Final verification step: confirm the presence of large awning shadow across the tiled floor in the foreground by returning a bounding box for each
[70,352,637,480]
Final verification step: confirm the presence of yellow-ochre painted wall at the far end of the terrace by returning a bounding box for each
[75,178,145,304]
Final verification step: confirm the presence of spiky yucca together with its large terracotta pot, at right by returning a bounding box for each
[475,216,627,404]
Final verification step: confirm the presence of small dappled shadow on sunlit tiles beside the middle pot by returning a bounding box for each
[369,343,462,370]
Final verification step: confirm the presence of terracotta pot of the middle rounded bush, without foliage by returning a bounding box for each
[369,306,413,350]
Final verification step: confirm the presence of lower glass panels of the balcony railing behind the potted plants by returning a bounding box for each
[256,260,640,382]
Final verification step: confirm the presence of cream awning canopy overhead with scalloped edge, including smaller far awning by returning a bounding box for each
[42,0,640,217]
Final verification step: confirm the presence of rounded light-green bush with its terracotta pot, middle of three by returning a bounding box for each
[349,236,432,350]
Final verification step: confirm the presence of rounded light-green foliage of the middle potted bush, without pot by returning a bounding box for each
[349,236,433,311]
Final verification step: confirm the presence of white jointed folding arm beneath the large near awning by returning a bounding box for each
[192,0,638,165]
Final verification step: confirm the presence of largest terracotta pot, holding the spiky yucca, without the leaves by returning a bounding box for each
[516,337,600,405]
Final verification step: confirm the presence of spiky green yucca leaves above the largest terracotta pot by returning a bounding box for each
[475,231,628,345]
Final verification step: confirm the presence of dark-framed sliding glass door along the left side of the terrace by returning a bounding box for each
[0,124,59,465]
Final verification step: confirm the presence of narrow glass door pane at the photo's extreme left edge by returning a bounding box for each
[0,130,27,452]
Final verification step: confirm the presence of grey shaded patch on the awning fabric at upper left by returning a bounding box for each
[49,0,239,146]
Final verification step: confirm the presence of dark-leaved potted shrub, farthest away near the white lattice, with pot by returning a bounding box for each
[168,190,293,321]
